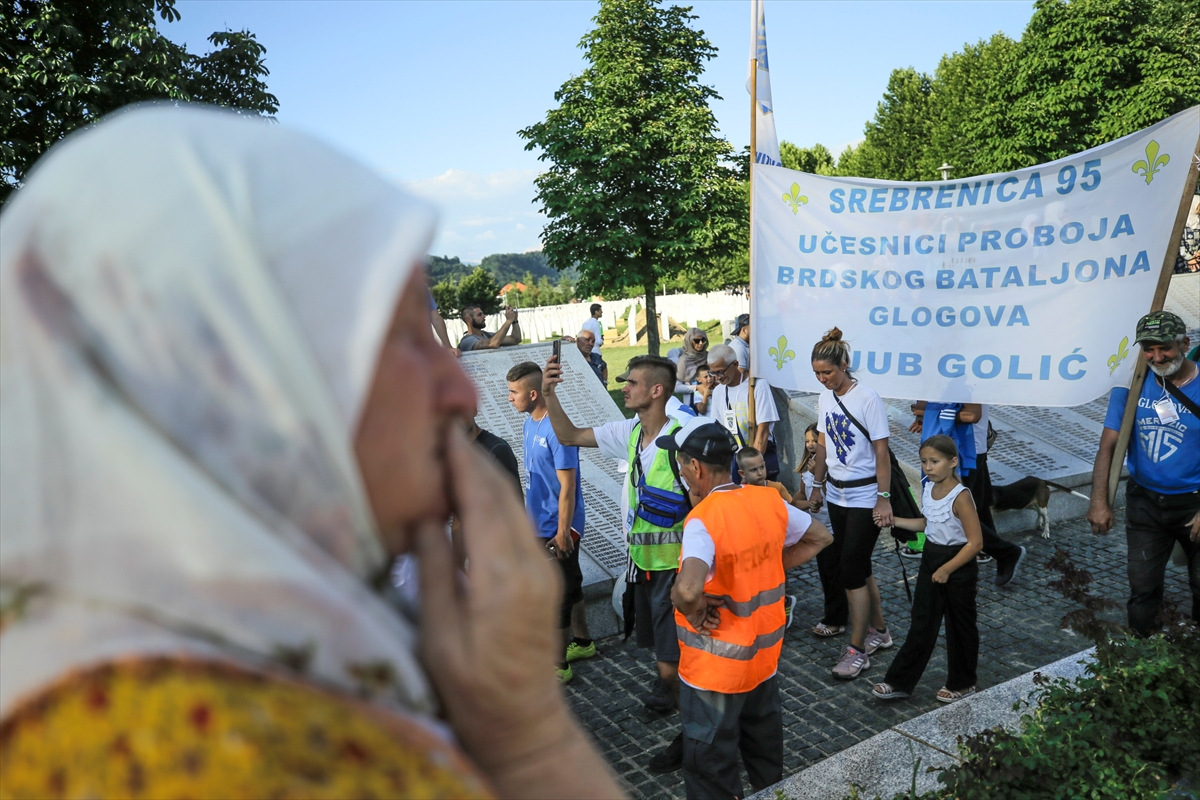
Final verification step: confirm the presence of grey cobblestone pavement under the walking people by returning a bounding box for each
[568,511,1190,798]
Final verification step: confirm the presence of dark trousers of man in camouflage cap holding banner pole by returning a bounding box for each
[1126,481,1200,636]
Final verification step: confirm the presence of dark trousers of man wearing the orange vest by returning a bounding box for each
[679,675,784,800]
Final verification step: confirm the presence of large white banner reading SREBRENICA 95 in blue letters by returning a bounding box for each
[750,107,1200,405]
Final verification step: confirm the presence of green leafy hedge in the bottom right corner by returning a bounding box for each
[851,551,1200,800]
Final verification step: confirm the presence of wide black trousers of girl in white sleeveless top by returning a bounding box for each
[883,540,979,693]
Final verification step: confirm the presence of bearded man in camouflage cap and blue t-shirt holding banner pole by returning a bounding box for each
[1087,311,1200,636]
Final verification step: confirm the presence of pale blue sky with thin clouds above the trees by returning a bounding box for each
[161,0,1033,261]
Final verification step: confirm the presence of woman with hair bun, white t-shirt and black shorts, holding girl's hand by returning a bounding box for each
[809,327,892,680]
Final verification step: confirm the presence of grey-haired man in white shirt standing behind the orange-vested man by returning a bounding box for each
[696,344,779,483]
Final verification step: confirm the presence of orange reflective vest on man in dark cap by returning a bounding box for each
[676,486,787,694]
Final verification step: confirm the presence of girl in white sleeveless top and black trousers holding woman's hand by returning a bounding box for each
[871,435,983,703]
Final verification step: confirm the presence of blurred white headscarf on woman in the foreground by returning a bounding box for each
[0,106,434,715]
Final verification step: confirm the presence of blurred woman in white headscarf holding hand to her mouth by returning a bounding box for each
[0,107,619,798]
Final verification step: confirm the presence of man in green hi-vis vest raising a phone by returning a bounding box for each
[542,355,691,772]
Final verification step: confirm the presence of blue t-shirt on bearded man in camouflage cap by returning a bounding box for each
[1104,373,1200,494]
